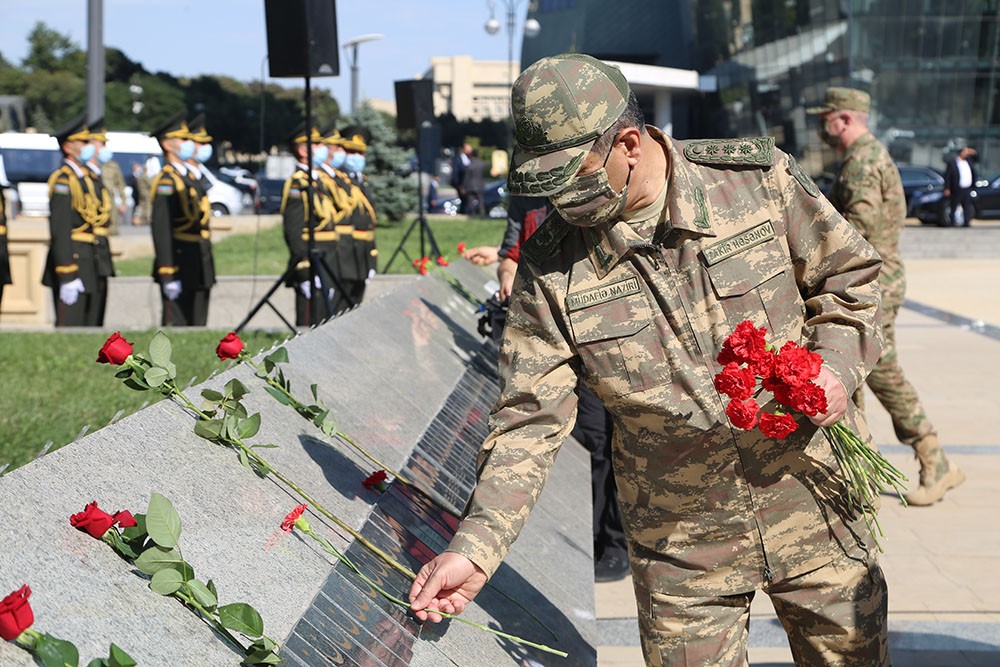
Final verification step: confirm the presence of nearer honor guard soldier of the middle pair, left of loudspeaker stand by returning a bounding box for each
[150,112,215,326]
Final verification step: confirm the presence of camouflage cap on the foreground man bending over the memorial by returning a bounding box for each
[507,53,629,196]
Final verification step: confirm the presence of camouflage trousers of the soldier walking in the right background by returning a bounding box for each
[854,279,937,447]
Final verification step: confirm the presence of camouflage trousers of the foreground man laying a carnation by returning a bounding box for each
[636,557,892,667]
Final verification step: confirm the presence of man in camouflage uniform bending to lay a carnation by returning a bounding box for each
[410,54,889,667]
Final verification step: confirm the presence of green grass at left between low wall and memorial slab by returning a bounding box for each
[0,329,288,470]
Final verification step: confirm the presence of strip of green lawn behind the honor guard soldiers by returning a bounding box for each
[115,216,507,276]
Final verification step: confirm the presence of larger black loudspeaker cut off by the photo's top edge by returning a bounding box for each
[264,0,340,77]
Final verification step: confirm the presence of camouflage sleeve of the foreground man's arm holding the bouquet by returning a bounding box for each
[774,153,882,395]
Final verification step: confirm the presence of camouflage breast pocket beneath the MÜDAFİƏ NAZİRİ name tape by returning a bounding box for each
[569,294,669,396]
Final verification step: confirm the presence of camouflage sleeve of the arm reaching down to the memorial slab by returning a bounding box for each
[448,263,578,576]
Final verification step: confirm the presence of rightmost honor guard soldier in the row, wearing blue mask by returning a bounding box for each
[338,125,378,312]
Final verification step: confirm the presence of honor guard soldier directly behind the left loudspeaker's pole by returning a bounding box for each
[281,123,342,326]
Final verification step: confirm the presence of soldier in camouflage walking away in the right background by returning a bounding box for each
[808,87,965,505]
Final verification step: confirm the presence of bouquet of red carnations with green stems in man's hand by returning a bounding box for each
[715,321,906,551]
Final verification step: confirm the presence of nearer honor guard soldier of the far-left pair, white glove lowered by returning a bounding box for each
[42,116,104,327]
